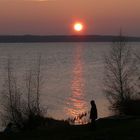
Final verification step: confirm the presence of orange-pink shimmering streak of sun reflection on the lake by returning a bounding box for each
[67,46,86,117]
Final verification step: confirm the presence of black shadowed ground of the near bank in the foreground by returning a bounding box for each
[0,118,140,140]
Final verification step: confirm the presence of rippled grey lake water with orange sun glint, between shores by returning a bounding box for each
[0,43,140,119]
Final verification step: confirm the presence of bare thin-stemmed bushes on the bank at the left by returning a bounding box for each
[1,57,45,131]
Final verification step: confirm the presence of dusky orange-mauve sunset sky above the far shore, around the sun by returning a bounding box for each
[0,0,140,36]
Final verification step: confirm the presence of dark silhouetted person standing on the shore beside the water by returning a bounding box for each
[90,100,97,129]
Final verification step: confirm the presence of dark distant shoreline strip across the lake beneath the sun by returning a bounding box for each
[0,35,140,43]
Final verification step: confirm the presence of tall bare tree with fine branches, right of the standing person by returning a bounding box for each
[104,32,140,115]
